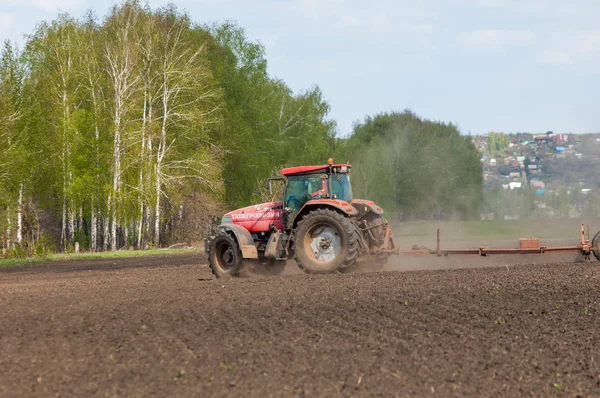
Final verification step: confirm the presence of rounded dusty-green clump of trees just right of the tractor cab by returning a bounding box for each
[338,111,482,219]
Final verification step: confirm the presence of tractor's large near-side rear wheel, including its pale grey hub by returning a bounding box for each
[292,209,359,274]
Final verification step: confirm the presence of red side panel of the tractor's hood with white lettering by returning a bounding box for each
[226,202,283,232]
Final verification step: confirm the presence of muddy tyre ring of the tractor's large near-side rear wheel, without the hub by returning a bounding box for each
[292,209,359,274]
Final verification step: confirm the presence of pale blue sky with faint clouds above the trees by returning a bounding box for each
[0,0,600,135]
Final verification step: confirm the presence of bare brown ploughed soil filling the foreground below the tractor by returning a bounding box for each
[0,255,600,397]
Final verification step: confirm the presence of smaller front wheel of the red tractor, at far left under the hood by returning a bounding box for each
[208,232,244,278]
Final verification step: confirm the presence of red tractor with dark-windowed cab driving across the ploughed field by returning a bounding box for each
[205,159,398,277]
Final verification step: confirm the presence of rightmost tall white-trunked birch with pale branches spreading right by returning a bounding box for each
[154,9,220,245]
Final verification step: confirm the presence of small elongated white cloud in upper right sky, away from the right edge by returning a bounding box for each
[461,29,536,50]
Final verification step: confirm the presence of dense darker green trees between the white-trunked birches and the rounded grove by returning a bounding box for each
[203,22,335,207]
